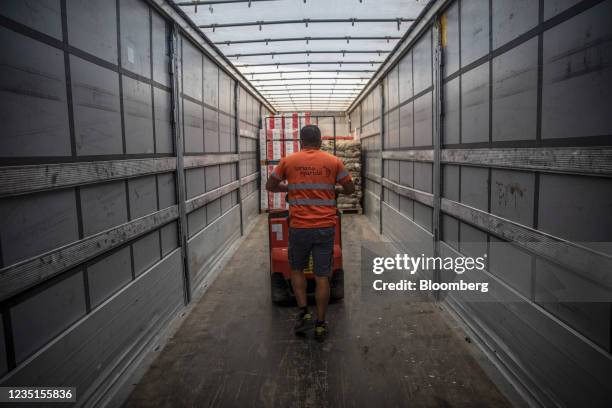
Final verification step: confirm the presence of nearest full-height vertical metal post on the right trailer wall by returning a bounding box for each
[433,16,444,300]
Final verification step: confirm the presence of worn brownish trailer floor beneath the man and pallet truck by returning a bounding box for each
[125,215,510,407]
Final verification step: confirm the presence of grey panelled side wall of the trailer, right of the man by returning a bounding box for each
[350,0,612,406]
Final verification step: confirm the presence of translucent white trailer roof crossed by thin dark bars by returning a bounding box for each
[175,0,427,111]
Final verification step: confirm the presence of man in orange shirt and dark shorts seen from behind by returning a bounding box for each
[266,125,355,339]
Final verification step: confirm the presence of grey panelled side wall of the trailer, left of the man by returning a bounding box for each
[0,0,263,405]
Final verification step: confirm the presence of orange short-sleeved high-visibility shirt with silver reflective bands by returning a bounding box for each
[272,148,351,228]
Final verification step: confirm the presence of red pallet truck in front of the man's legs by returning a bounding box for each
[268,210,344,303]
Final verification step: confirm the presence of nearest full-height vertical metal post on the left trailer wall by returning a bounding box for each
[170,24,191,304]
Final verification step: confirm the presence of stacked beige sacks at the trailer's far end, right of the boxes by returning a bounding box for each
[321,140,362,212]
